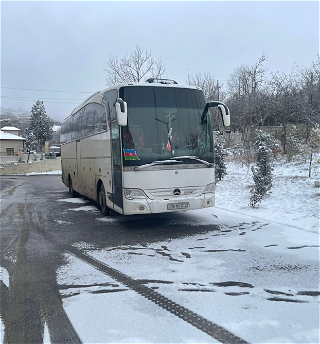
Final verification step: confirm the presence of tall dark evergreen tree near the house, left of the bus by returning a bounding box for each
[28,100,53,152]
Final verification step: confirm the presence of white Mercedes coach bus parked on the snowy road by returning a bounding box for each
[61,78,230,215]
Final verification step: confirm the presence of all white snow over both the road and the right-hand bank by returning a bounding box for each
[1,157,320,343]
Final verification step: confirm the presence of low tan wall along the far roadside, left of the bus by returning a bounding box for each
[0,157,61,175]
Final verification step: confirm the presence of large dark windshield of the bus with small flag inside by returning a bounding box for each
[119,86,213,166]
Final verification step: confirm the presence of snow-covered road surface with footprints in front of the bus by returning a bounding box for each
[58,209,320,343]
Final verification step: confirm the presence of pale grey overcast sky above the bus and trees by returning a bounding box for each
[1,1,319,120]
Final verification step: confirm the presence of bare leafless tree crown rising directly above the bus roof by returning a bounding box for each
[105,45,166,86]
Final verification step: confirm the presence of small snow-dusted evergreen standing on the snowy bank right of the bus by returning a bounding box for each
[250,130,275,208]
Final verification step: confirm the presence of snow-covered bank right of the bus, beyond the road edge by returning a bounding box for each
[216,159,320,232]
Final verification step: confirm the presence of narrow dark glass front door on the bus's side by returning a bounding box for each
[111,121,123,212]
